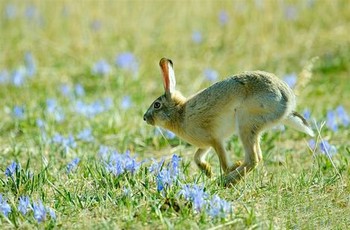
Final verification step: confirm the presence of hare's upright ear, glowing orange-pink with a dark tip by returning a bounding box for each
[159,58,176,96]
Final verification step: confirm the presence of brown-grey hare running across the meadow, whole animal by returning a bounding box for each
[143,58,314,185]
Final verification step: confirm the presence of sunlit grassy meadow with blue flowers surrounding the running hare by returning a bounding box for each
[0,0,350,229]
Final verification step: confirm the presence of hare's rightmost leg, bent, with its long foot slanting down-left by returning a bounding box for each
[225,125,262,185]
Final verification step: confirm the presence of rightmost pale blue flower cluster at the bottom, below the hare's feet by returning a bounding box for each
[207,195,232,218]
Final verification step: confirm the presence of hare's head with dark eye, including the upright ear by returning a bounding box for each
[143,58,185,129]
